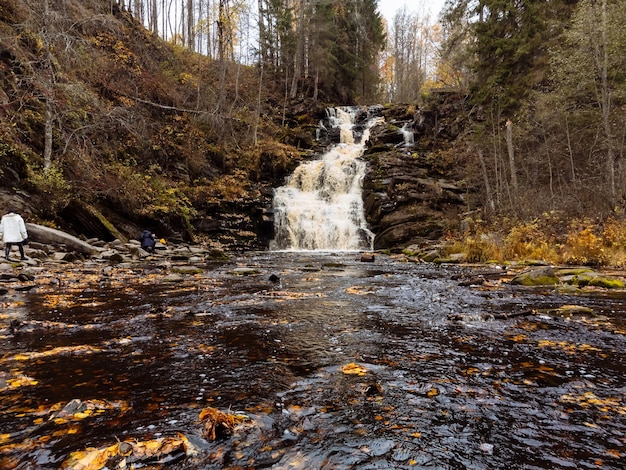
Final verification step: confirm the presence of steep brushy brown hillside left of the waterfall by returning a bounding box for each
[0,0,324,248]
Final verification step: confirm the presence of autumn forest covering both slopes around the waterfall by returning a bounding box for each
[0,0,626,264]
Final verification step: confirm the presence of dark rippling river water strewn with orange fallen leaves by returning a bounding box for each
[0,252,626,469]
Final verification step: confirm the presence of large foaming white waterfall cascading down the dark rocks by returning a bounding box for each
[270,108,382,251]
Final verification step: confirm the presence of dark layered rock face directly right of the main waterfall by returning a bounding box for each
[363,101,467,250]
